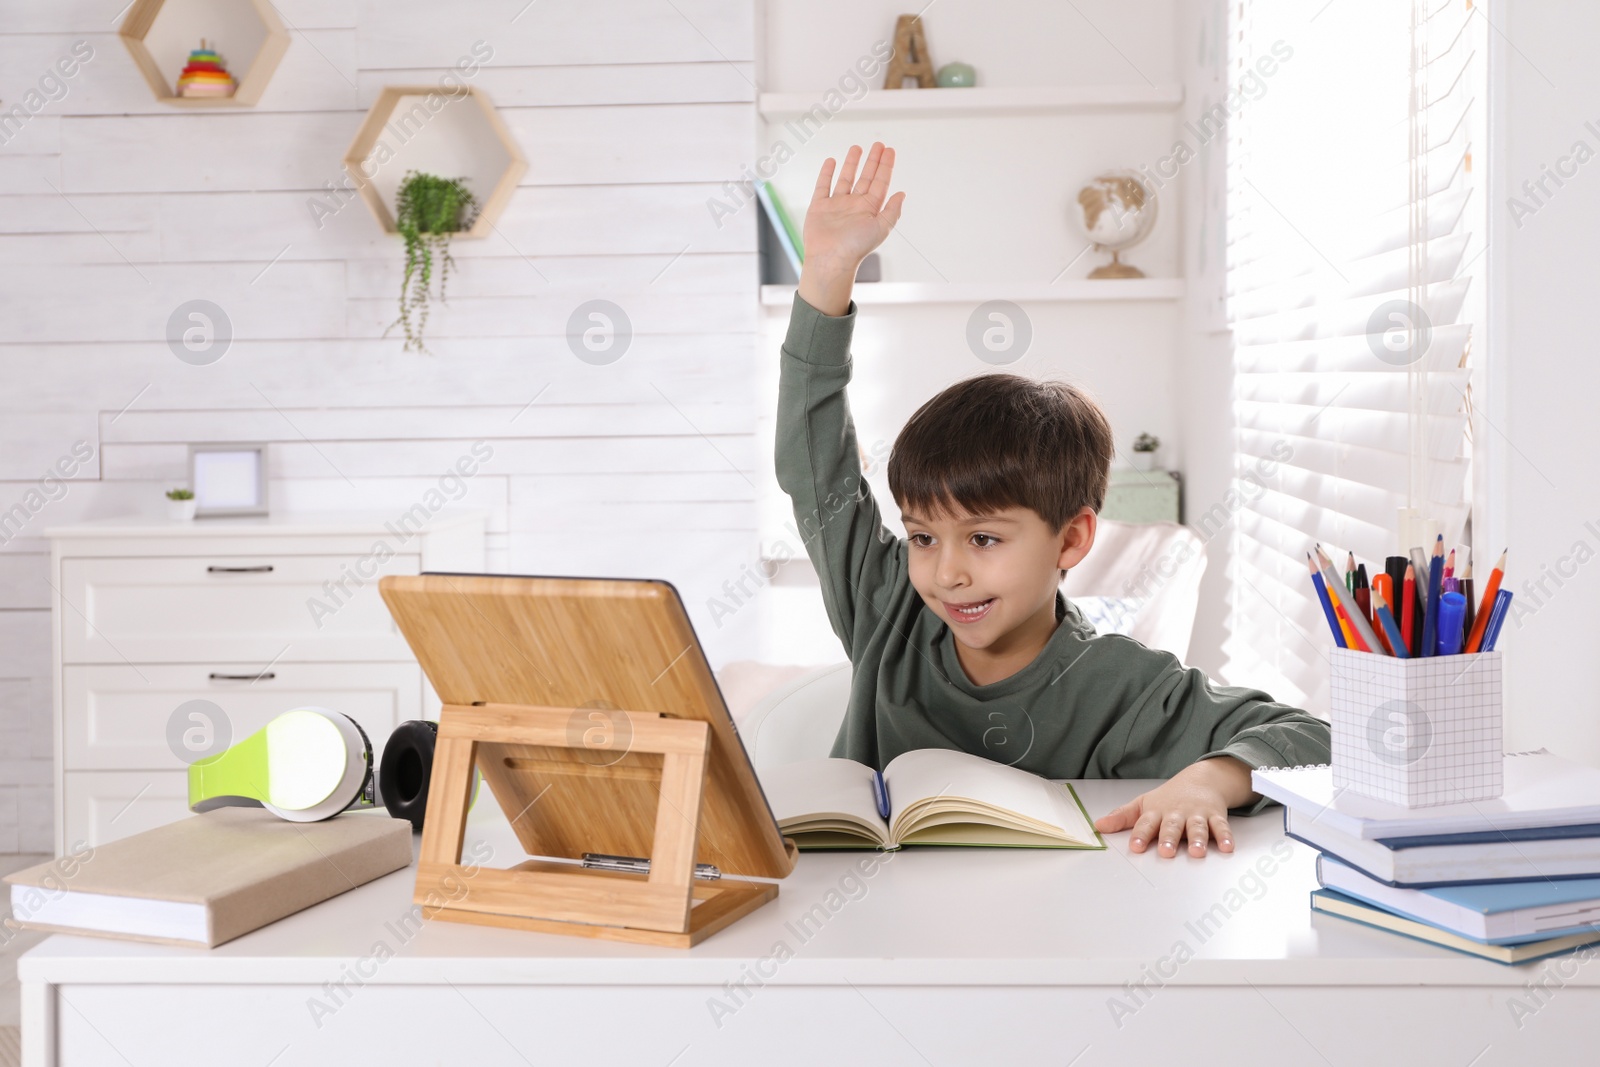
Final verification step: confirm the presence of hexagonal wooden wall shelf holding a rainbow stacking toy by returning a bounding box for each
[117,0,290,107]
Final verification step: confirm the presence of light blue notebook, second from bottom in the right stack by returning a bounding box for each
[1317,856,1600,944]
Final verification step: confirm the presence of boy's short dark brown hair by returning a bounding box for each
[890,373,1115,577]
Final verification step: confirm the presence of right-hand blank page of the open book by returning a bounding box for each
[883,749,1098,843]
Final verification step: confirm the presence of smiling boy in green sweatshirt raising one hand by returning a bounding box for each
[776,142,1330,857]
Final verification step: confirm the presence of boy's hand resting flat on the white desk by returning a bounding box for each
[1094,755,1256,859]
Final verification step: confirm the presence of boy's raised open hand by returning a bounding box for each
[800,141,906,315]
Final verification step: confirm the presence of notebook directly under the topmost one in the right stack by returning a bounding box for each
[1283,808,1600,889]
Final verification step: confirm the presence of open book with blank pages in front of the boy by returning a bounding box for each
[762,749,1106,849]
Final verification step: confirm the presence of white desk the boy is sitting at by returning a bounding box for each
[18,781,1600,1067]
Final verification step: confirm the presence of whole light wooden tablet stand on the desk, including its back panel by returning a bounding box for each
[378,573,798,949]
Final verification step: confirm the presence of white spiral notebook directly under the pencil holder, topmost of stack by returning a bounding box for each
[1250,749,1600,840]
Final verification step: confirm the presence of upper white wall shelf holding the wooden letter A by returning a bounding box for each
[758,82,1184,118]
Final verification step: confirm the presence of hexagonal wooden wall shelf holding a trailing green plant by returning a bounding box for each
[344,85,528,237]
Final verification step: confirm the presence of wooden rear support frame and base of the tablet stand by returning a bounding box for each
[413,704,794,949]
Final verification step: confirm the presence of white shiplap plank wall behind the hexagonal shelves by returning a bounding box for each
[0,0,760,853]
